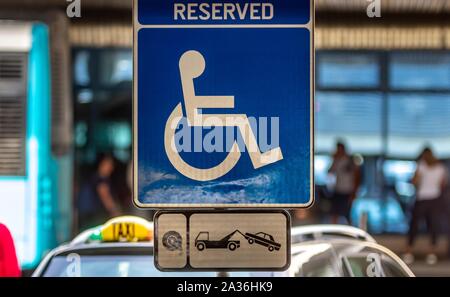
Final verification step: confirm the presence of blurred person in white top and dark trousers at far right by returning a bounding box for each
[404,148,448,264]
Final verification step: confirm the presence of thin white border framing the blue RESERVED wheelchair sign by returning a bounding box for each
[132,0,316,209]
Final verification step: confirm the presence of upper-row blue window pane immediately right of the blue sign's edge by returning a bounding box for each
[317,53,380,88]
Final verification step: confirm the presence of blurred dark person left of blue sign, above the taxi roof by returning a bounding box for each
[78,154,121,229]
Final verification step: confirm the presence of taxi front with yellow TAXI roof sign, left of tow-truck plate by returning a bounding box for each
[32,217,250,277]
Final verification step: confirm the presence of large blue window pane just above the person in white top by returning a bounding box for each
[388,93,450,159]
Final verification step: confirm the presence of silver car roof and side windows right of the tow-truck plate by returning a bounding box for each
[267,225,414,277]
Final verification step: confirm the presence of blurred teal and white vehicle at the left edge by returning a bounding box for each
[0,21,72,269]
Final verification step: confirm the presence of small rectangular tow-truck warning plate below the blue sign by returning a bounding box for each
[155,211,290,271]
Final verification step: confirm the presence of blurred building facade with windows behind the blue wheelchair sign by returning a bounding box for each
[0,0,450,268]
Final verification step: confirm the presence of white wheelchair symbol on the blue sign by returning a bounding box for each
[164,50,283,181]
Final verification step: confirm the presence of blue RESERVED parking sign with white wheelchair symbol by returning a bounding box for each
[133,0,314,208]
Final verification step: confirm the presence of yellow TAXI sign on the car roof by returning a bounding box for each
[100,216,153,242]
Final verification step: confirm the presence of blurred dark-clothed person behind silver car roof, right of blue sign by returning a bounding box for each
[328,141,360,224]
